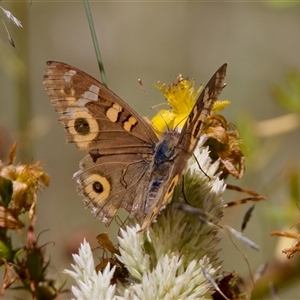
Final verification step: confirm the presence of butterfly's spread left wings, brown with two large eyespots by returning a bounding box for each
[43,62,158,225]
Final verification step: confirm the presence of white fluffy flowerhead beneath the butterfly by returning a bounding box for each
[66,139,225,299]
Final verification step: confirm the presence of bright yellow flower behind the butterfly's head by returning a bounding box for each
[151,74,230,135]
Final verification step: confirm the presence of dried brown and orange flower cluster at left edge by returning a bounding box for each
[0,144,64,300]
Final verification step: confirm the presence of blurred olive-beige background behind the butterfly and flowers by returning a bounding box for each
[0,1,300,299]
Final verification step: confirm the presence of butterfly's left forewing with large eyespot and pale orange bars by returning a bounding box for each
[44,62,157,154]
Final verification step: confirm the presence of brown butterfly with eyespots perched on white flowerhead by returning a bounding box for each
[43,61,227,231]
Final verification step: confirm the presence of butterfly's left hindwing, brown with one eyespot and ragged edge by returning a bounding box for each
[74,153,149,224]
